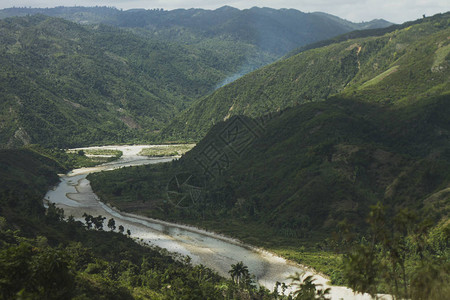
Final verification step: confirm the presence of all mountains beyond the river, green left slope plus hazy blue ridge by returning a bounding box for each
[0,7,387,147]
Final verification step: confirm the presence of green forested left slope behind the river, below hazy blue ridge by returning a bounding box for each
[0,16,250,147]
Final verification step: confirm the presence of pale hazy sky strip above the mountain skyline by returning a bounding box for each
[0,0,450,23]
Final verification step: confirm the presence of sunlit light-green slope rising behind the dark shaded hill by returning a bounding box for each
[163,13,450,139]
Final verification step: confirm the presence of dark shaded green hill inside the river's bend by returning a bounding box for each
[91,96,450,237]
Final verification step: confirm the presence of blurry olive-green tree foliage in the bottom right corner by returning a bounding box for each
[343,203,450,299]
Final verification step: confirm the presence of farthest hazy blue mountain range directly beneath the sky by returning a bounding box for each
[0,6,391,82]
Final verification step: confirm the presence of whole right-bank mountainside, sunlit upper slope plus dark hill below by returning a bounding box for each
[89,14,450,283]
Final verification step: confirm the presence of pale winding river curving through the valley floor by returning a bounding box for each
[45,145,386,299]
